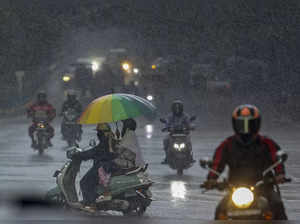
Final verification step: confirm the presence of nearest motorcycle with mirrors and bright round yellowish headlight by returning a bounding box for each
[199,151,291,220]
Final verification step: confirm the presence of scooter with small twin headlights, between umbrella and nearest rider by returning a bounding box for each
[160,116,196,176]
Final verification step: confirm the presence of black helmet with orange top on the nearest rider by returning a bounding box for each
[232,104,261,137]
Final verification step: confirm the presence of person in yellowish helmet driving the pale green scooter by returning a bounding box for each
[74,124,135,207]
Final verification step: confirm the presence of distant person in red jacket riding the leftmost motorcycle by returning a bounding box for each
[27,91,56,148]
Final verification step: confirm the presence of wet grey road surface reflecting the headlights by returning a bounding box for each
[0,117,300,223]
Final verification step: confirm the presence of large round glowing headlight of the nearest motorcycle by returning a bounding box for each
[231,187,254,208]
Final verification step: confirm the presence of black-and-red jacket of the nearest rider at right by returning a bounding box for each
[208,135,285,184]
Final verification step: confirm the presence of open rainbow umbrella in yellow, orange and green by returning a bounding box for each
[78,93,156,124]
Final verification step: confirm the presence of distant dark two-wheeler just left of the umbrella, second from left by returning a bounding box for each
[62,108,82,147]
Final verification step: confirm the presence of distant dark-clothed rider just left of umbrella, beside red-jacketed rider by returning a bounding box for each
[60,90,82,141]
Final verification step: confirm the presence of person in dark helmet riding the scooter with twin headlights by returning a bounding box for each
[161,100,191,164]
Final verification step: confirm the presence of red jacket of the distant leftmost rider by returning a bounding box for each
[27,102,56,122]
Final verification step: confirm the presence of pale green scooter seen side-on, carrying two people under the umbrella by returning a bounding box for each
[46,143,153,216]
